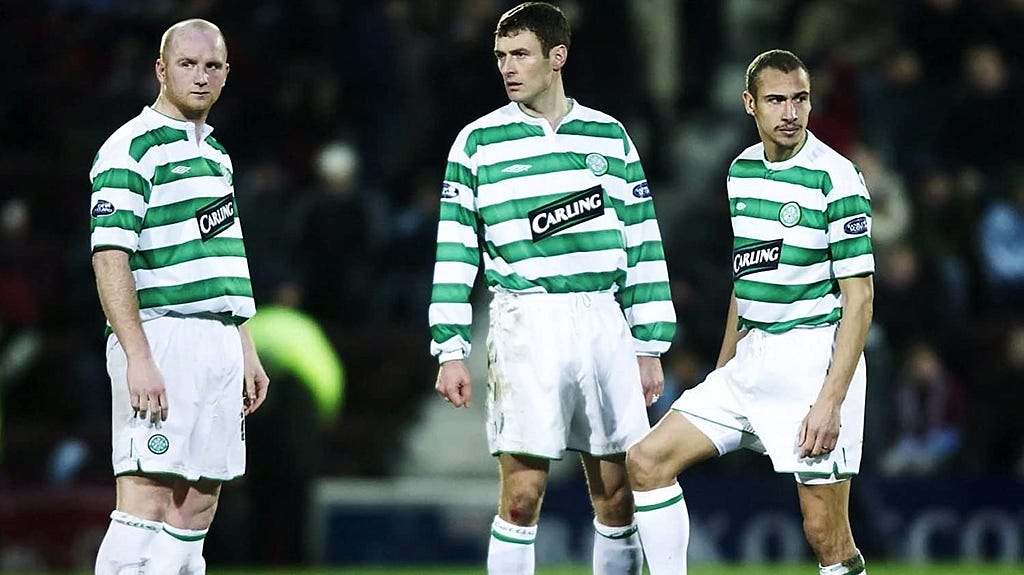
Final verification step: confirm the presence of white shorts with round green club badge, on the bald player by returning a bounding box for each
[106,316,246,481]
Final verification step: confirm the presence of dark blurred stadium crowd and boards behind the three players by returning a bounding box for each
[0,0,1024,574]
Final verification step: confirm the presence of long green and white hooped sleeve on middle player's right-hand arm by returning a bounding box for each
[608,129,676,356]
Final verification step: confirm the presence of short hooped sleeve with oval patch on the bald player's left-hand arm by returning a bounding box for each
[89,147,152,253]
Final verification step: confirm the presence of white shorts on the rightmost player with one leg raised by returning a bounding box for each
[672,325,866,485]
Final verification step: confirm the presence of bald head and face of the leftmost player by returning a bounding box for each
[157,29,230,120]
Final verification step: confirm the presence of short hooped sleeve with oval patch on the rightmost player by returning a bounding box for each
[825,165,874,279]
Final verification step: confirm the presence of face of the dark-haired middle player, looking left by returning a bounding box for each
[495,31,557,106]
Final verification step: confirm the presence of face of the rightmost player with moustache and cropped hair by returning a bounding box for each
[743,68,811,162]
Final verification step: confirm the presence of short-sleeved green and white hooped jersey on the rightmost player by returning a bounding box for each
[727,132,874,334]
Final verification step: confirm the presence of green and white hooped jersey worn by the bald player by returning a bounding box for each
[89,106,256,323]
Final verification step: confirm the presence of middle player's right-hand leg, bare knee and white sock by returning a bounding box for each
[581,453,643,575]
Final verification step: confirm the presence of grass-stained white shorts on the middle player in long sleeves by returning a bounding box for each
[486,293,650,459]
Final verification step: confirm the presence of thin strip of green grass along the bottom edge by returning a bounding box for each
[36,561,1024,575]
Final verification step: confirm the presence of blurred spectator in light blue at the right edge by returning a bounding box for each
[978,165,1024,313]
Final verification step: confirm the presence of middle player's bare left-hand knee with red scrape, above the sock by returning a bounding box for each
[498,453,551,525]
